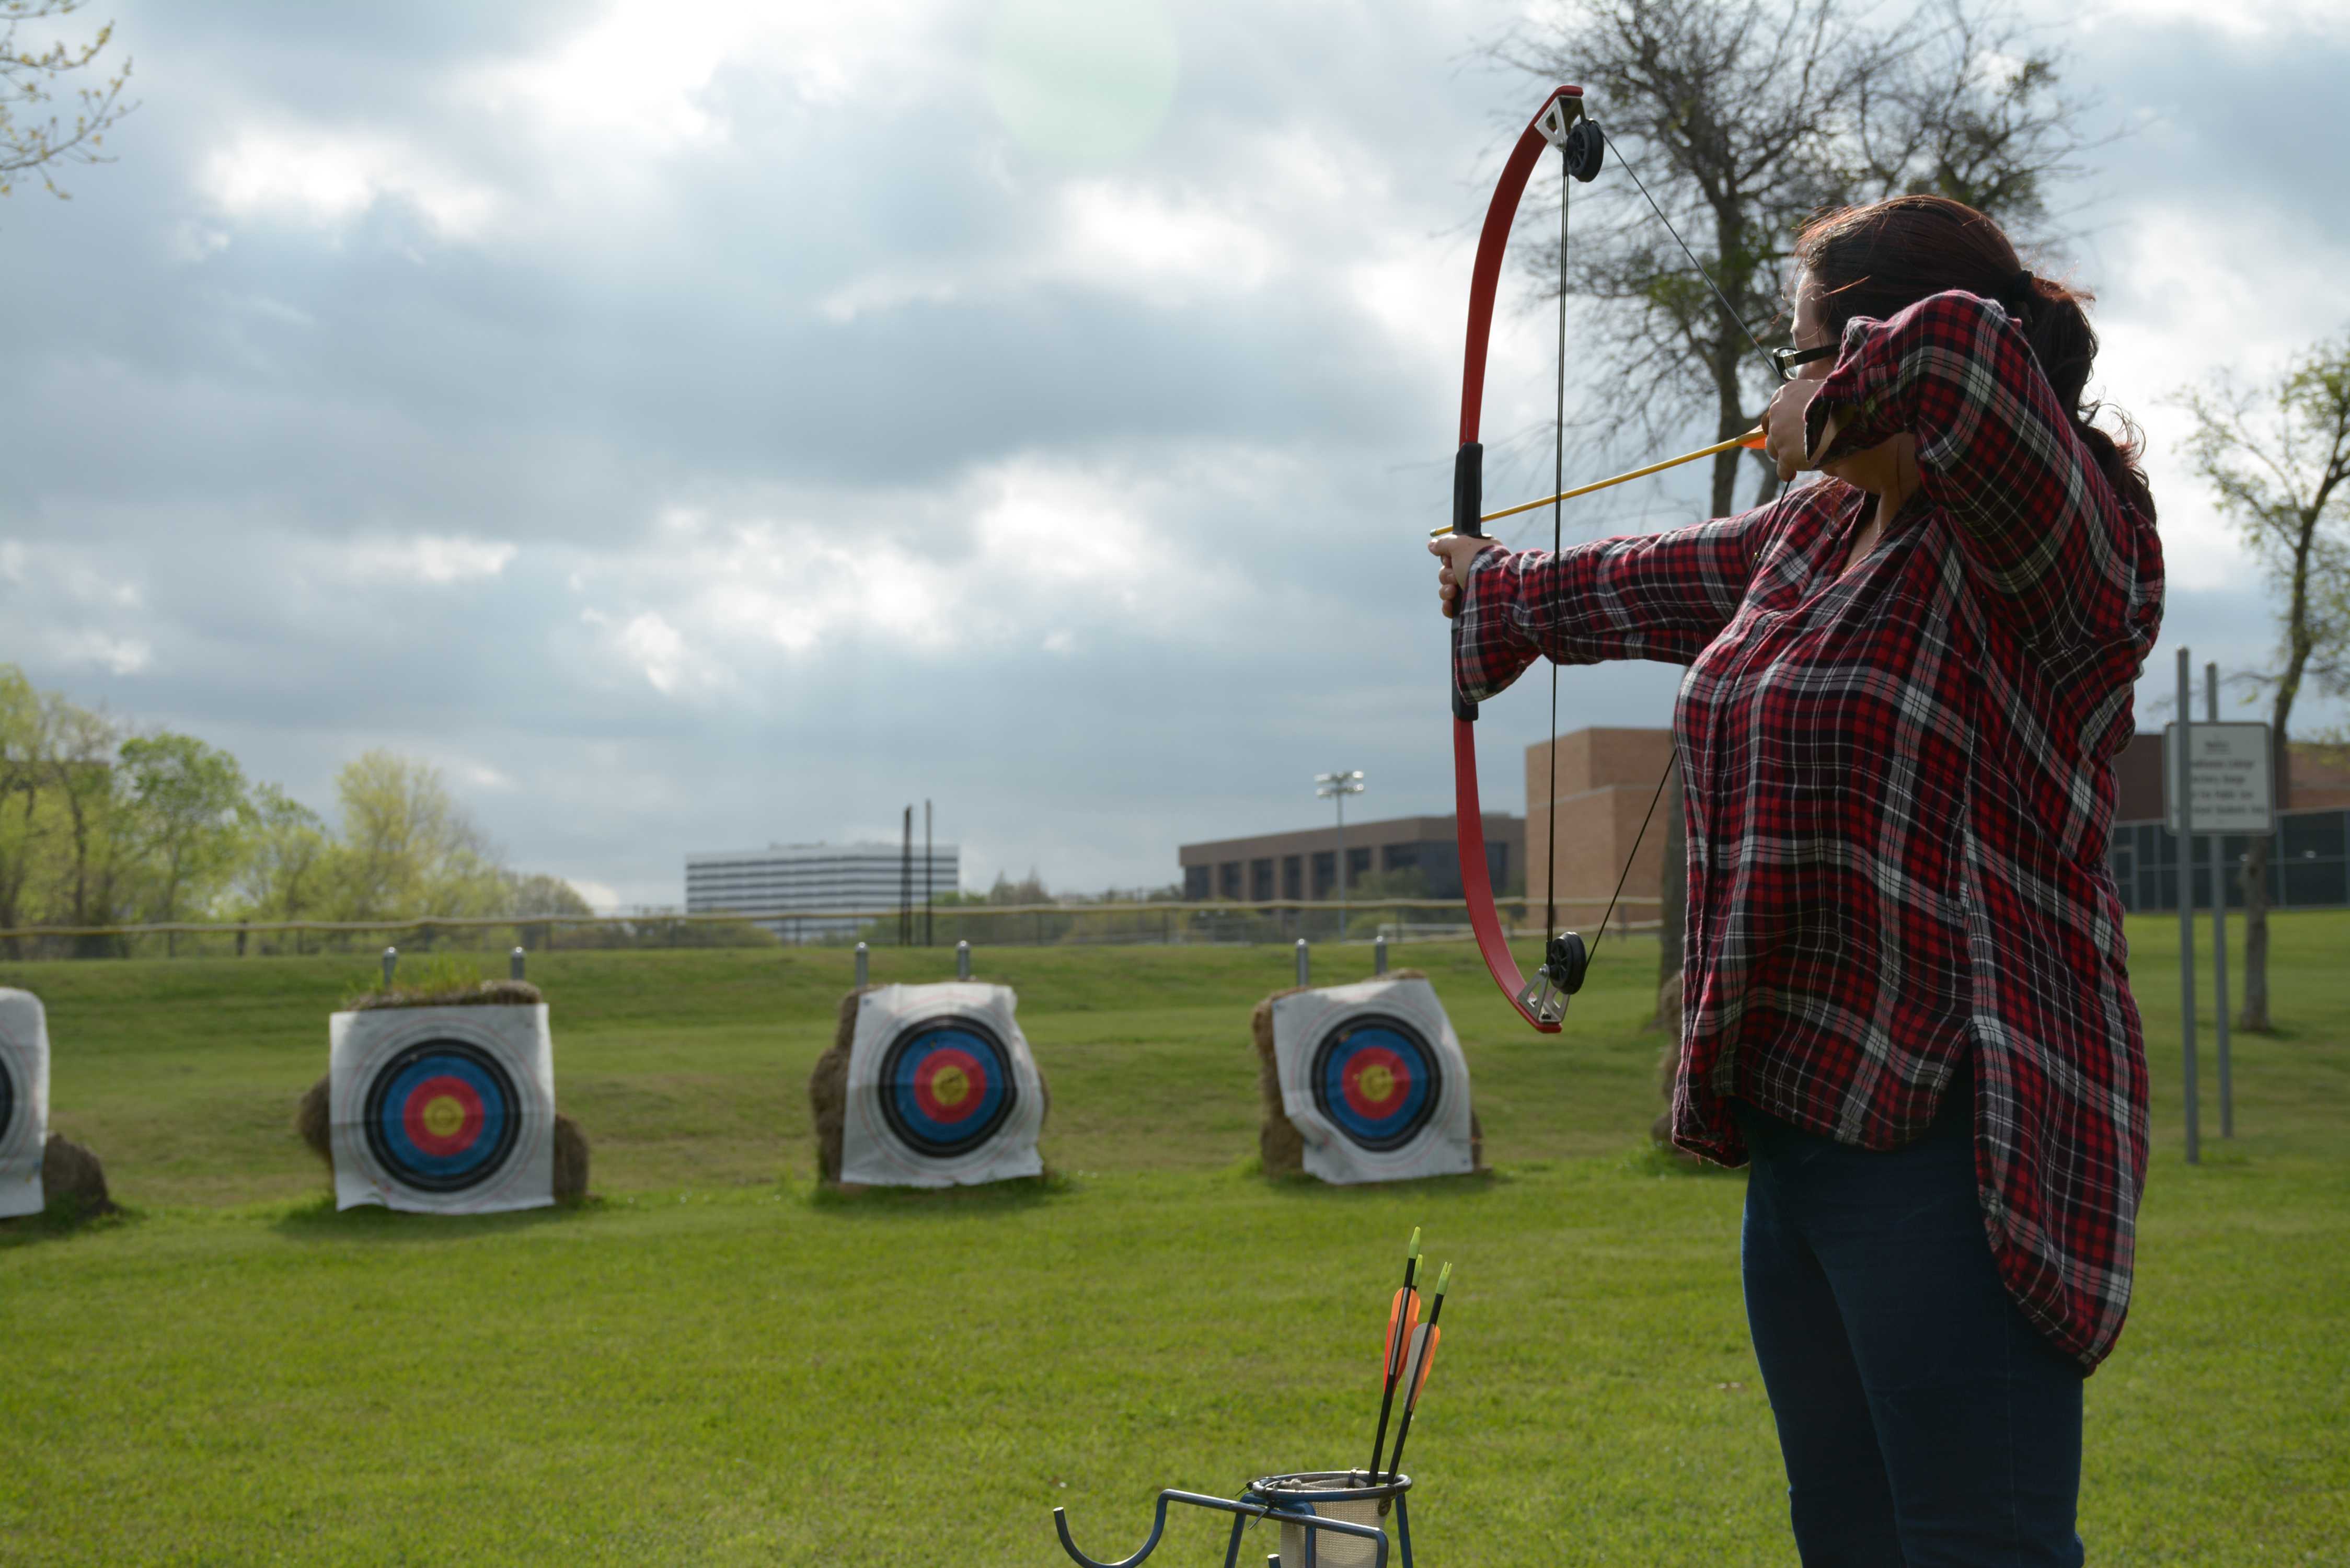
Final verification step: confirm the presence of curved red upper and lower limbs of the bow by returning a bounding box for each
[1453,87,1584,1034]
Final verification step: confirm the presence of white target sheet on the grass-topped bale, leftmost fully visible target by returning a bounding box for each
[327,1004,555,1213]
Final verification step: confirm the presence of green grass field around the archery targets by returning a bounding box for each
[0,915,2350,1568]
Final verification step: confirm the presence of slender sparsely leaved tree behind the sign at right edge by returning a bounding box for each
[2181,331,2350,1030]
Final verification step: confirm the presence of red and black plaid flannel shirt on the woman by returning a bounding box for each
[1455,294,2162,1368]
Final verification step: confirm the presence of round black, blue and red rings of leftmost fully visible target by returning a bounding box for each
[362,1039,522,1192]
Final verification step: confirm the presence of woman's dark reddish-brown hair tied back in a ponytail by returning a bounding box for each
[1795,195,2155,522]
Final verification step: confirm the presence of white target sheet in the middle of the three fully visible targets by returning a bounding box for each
[842,981,1043,1187]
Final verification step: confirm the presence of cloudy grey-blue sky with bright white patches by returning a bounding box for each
[0,0,2350,905]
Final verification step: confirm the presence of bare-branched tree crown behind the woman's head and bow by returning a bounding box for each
[1485,0,2096,515]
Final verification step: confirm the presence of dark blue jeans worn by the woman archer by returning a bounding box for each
[1732,1072,2084,1568]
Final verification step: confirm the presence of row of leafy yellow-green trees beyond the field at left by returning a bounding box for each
[0,665,592,957]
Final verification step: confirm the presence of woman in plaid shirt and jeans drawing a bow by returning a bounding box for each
[1431,195,2162,1568]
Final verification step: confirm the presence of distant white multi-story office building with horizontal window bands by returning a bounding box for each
[686,844,963,943]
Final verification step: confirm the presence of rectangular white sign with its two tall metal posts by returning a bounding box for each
[2162,686,2277,1163]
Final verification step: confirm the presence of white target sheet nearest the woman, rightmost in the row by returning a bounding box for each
[1274,981,1476,1182]
